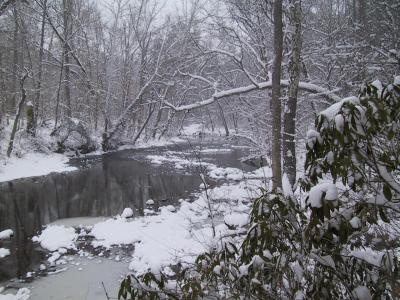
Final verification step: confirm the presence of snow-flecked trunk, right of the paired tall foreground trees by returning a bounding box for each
[282,0,302,186]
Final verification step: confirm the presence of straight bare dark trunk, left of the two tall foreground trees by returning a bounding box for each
[271,0,283,190]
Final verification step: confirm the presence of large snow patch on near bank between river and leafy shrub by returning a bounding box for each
[89,169,262,274]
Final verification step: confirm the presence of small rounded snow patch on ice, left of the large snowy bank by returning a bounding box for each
[32,225,78,251]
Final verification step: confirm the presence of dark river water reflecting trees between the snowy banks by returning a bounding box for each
[0,142,253,282]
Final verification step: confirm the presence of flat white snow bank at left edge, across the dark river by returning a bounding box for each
[0,152,76,182]
